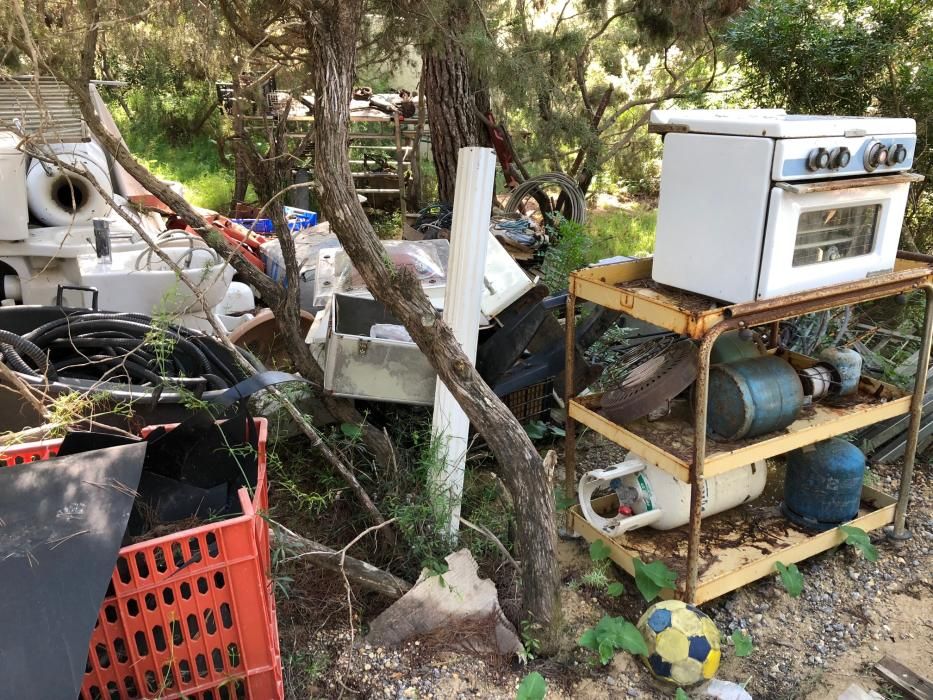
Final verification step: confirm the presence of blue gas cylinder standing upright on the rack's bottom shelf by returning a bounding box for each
[781,438,865,532]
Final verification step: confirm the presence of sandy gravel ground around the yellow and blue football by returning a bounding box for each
[289,434,933,700]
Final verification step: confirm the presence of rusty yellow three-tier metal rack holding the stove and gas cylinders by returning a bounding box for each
[564,253,933,604]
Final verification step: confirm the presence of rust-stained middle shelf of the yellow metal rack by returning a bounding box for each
[570,377,910,482]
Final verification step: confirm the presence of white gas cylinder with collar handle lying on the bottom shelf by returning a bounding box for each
[577,455,768,537]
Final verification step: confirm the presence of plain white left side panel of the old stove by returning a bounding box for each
[652,133,774,302]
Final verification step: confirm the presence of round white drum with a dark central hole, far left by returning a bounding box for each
[26,143,113,226]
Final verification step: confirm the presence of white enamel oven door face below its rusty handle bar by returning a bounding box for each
[757,183,910,299]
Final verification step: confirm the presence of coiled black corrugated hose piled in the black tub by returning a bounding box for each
[0,311,245,390]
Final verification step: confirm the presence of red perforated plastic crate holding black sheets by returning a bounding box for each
[0,419,284,700]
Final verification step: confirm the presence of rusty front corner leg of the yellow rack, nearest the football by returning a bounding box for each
[684,322,732,603]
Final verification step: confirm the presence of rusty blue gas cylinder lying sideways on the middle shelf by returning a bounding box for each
[707,355,803,440]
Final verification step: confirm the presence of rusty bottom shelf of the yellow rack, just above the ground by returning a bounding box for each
[570,474,896,604]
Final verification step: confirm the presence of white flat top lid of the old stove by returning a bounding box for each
[650,109,917,138]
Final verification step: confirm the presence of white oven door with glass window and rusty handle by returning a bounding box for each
[758,174,914,299]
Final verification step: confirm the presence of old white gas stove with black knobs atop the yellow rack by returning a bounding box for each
[650,109,922,303]
